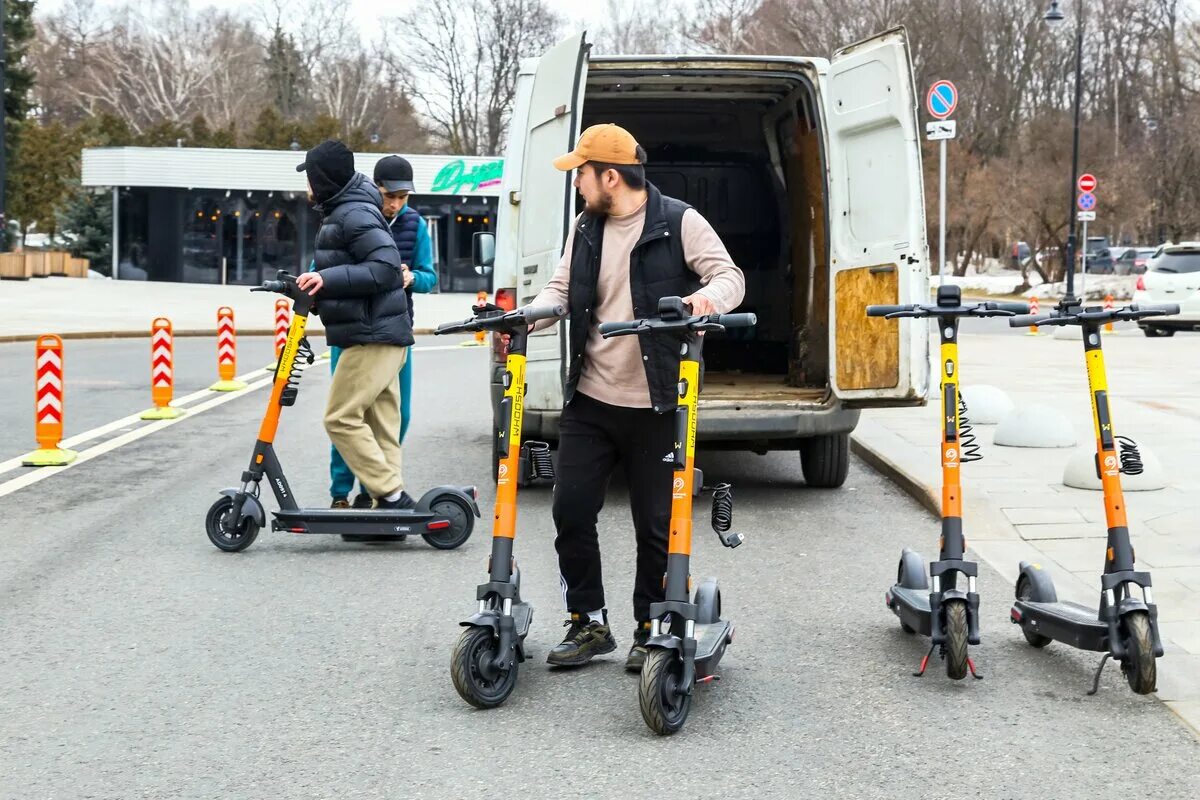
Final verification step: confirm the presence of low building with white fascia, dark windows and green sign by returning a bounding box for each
[83,148,504,291]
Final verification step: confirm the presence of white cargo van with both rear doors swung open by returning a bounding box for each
[480,29,929,487]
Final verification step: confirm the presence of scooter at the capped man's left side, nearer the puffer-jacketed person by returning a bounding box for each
[434,299,565,709]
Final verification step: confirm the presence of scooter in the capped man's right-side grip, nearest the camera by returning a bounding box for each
[600,297,757,735]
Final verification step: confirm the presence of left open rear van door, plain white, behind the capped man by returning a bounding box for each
[508,34,589,408]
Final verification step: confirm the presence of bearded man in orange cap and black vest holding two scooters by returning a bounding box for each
[532,125,745,670]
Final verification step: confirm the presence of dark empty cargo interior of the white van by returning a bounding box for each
[582,60,829,403]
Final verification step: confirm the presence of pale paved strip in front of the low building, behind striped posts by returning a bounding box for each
[0,277,487,342]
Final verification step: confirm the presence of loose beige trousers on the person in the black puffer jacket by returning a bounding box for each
[325,344,408,499]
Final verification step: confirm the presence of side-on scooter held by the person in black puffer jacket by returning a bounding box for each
[205,271,479,553]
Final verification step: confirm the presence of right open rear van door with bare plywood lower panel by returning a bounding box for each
[823,28,929,407]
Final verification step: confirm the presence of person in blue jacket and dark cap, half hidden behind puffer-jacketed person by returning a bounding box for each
[329,156,438,509]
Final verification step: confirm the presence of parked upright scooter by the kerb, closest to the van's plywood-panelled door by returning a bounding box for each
[866,285,1030,680]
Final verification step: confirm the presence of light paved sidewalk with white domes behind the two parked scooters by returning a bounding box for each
[853,321,1200,732]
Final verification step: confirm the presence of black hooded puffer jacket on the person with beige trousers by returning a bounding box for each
[314,173,413,347]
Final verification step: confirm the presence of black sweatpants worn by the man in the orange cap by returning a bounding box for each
[553,392,674,622]
